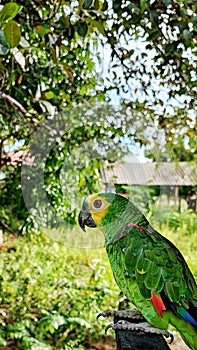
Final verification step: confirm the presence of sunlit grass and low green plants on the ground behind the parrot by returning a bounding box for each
[0,220,197,350]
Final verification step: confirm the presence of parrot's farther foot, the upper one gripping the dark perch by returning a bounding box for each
[97,310,145,323]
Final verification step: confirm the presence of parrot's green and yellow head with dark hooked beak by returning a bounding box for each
[78,193,130,231]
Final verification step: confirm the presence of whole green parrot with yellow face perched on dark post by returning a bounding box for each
[78,193,197,350]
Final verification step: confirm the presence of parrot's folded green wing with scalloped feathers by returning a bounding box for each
[125,227,197,327]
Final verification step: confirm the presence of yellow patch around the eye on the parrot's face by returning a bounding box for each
[86,194,110,226]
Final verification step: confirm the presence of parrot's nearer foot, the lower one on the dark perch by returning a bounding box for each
[105,320,174,344]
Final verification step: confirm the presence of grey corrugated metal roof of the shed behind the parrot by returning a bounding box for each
[101,162,197,186]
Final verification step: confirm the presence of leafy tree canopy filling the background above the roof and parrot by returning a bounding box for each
[0,0,196,232]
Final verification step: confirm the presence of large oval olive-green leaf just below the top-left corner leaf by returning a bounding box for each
[3,21,21,48]
